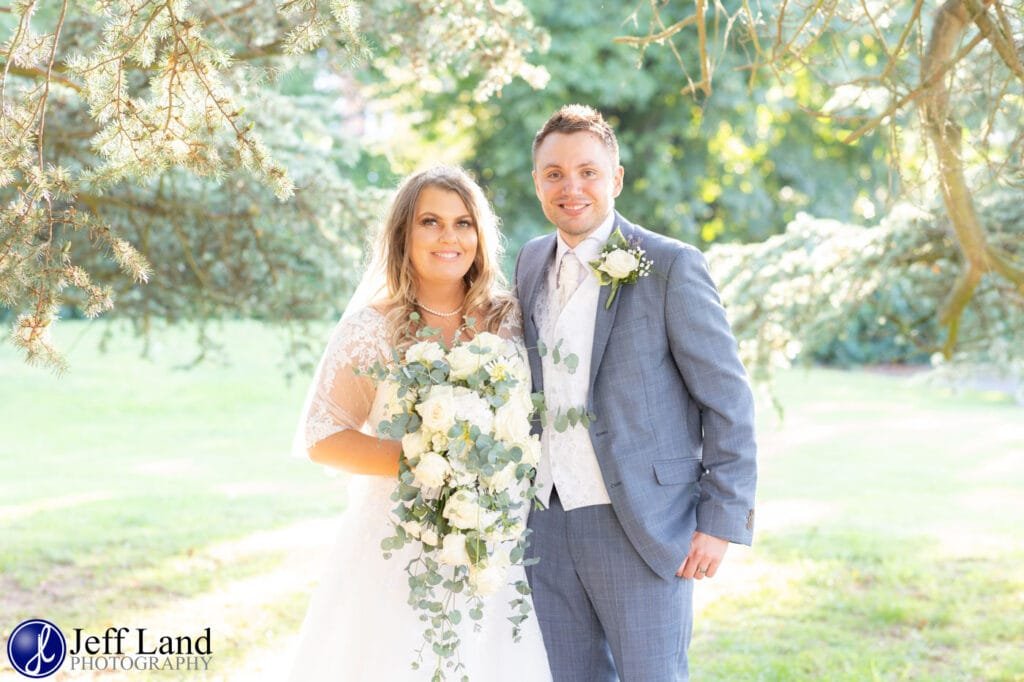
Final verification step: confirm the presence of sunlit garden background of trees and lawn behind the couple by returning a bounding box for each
[0,0,1024,682]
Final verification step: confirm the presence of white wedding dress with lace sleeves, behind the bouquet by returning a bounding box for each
[289,307,551,682]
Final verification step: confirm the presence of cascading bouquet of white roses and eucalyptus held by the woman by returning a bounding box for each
[374,323,541,679]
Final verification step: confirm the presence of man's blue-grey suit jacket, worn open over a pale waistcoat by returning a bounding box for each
[515,212,757,579]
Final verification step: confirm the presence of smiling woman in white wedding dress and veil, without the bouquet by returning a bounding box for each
[290,166,551,682]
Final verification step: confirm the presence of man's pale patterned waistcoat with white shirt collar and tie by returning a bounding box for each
[536,212,615,511]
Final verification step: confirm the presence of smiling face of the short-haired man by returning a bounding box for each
[534,132,623,247]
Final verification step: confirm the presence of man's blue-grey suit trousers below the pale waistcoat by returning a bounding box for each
[526,492,693,682]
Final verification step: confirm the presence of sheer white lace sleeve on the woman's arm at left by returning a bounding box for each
[292,308,385,457]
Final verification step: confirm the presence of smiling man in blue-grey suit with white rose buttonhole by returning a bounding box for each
[515,104,757,682]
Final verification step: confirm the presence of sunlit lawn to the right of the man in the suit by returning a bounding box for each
[690,370,1024,681]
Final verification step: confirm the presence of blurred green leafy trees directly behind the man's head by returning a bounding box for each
[384,0,889,260]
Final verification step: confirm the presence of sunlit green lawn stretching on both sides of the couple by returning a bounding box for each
[0,323,1024,681]
